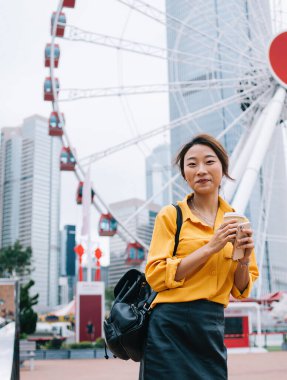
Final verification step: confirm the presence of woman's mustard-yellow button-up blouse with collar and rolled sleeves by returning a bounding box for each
[145,194,259,306]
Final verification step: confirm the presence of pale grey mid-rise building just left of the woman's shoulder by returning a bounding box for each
[108,198,160,286]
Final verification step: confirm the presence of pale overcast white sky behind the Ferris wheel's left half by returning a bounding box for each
[0,0,168,258]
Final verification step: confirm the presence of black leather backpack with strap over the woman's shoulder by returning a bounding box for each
[104,205,182,362]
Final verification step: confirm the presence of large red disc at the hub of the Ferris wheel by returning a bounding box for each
[269,32,287,87]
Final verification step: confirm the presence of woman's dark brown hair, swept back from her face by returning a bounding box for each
[175,134,233,180]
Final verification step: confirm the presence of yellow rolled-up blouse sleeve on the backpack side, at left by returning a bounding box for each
[145,205,185,292]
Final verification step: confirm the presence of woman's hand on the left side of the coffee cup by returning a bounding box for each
[207,219,238,254]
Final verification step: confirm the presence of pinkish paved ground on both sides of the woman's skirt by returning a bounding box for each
[21,351,287,380]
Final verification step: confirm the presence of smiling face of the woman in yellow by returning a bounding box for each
[184,144,222,194]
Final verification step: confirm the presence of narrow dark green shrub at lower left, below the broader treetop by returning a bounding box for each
[20,280,39,334]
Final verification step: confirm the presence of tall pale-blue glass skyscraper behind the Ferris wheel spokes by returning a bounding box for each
[166,0,287,293]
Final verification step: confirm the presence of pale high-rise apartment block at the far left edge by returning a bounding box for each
[0,115,61,306]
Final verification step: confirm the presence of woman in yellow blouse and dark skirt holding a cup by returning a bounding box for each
[140,135,258,380]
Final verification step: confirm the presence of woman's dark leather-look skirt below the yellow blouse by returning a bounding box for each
[139,300,227,380]
